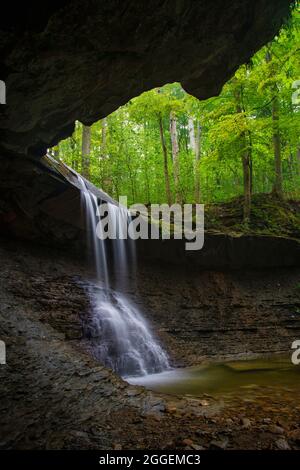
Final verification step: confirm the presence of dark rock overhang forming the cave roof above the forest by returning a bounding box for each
[0,0,292,157]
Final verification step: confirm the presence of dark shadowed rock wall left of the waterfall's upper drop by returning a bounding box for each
[0,156,114,246]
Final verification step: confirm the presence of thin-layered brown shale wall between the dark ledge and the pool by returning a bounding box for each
[133,265,300,364]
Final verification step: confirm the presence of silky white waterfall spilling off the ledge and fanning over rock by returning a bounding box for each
[78,176,169,377]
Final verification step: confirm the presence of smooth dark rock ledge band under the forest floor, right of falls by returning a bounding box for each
[137,235,300,270]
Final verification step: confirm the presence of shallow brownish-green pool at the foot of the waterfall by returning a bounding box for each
[128,357,300,396]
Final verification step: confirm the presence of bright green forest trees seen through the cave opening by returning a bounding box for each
[51,5,300,221]
